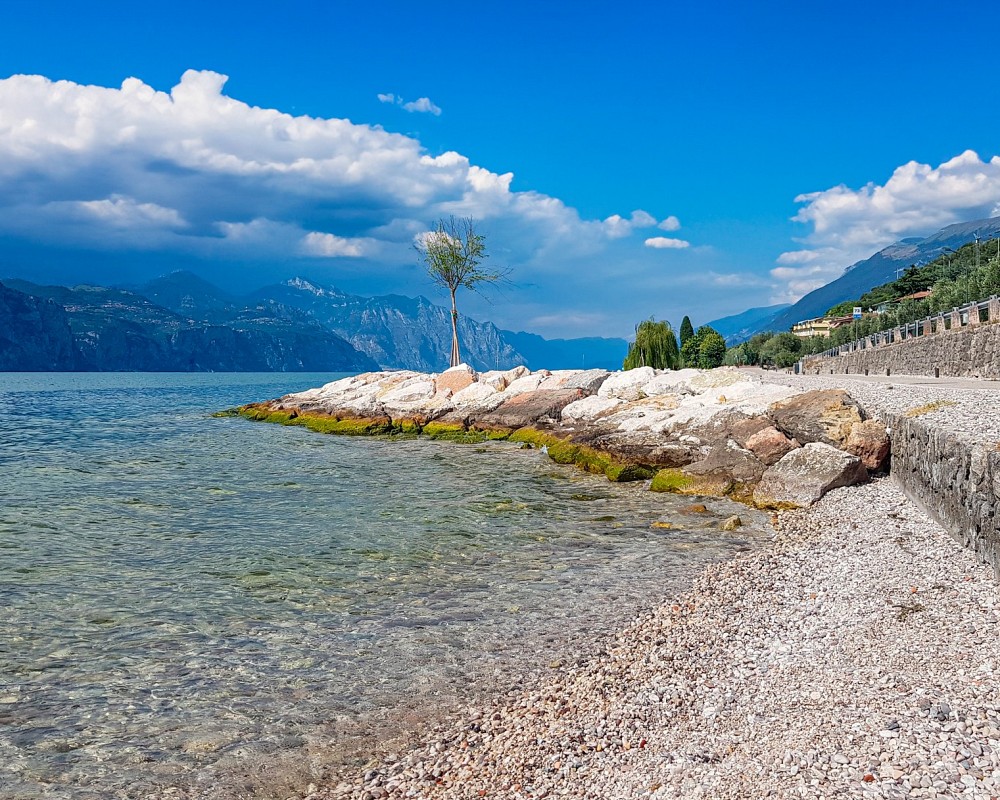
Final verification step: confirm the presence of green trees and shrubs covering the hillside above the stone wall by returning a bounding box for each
[726,234,1000,368]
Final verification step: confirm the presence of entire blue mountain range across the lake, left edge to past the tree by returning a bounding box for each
[0,271,628,372]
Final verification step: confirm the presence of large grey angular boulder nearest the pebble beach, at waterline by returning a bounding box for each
[753,442,868,508]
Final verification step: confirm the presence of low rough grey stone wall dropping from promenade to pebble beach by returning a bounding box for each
[887,416,1000,580]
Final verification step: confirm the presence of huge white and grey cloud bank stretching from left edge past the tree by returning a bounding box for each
[0,71,697,335]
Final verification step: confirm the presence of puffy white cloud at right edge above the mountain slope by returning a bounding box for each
[771,150,1000,300]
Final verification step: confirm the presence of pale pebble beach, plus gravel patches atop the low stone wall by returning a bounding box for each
[309,388,1000,800]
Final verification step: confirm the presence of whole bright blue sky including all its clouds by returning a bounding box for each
[0,0,1000,337]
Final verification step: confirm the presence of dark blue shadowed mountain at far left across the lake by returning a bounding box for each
[0,280,378,372]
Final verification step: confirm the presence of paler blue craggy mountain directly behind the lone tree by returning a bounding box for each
[251,278,525,372]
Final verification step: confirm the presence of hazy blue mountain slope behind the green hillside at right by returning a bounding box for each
[751,217,1000,333]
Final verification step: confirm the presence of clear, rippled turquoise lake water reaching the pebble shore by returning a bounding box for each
[0,373,760,800]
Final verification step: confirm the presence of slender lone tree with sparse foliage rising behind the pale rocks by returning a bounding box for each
[414,217,506,367]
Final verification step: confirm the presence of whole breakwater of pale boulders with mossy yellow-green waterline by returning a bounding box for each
[232,365,889,508]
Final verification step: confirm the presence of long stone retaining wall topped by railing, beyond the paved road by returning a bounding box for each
[803,323,1000,380]
